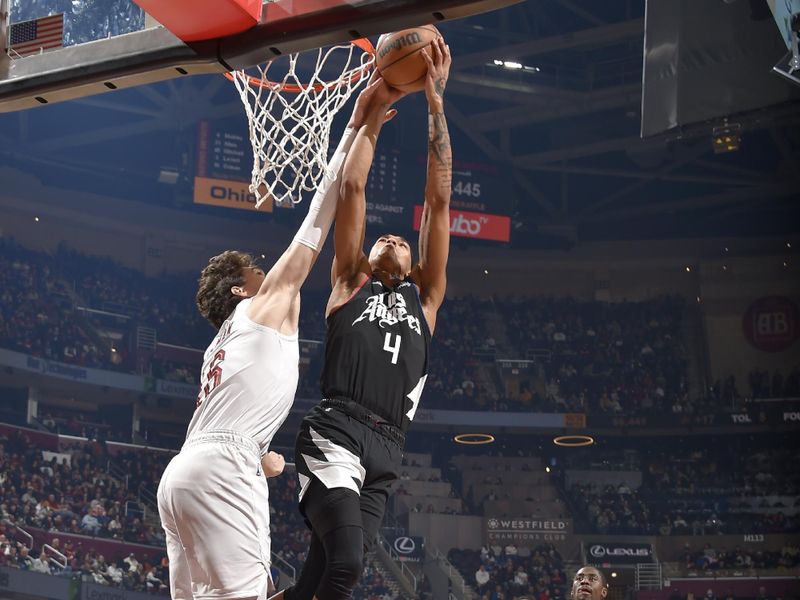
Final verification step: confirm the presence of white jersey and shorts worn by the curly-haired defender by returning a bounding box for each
[158,299,299,600]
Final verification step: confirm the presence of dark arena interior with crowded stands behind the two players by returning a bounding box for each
[0,0,800,600]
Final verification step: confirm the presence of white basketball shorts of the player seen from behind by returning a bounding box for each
[158,431,270,600]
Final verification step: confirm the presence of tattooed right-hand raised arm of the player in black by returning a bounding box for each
[412,38,453,332]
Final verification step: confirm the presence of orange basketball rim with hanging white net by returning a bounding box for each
[226,38,375,208]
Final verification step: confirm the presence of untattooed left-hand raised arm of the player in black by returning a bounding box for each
[331,78,404,290]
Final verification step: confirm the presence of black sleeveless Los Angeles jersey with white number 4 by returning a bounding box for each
[321,276,431,431]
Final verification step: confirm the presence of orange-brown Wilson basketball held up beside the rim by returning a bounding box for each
[375,25,441,92]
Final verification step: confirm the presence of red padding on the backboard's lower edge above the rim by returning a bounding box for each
[133,0,262,42]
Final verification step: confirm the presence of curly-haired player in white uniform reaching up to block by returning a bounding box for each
[158,77,396,600]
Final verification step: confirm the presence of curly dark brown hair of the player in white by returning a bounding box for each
[196,250,256,329]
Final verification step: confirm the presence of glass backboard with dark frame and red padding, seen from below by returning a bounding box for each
[0,0,520,112]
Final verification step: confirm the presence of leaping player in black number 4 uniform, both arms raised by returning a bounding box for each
[275,38,452,600]
